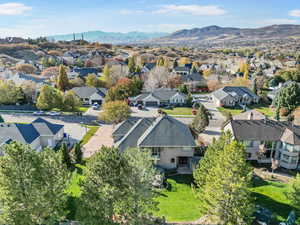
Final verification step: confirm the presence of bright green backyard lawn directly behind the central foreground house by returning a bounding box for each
[156,175,201,222]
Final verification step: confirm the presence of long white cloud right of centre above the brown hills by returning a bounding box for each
[154,5,227,16]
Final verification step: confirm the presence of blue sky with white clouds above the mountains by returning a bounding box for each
[0,0,300,37]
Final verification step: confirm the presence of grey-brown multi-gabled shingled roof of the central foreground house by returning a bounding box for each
[113,115,196,151]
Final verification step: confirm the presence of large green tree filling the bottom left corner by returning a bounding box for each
[0,142,69,225]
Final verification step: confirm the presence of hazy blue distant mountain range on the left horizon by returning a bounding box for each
[48,31,168,44]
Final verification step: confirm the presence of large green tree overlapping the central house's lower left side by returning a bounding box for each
[77,147,156,225]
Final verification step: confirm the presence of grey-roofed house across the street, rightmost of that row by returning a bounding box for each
[211,86,259,107]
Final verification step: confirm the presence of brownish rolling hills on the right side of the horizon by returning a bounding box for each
[155,24,300,44]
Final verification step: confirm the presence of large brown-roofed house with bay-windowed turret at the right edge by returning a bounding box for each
[224,119,300,169]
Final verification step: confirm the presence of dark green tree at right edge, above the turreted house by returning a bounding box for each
[272,82,300,113]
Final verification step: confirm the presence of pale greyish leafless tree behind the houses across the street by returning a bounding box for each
[145,66,175,91]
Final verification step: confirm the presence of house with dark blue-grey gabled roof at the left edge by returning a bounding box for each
[0,118,64,151]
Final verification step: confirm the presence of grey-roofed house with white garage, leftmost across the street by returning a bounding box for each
[72,87,107,105]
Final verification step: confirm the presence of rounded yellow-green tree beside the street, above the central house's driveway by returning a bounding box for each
[100,101,130,124]
